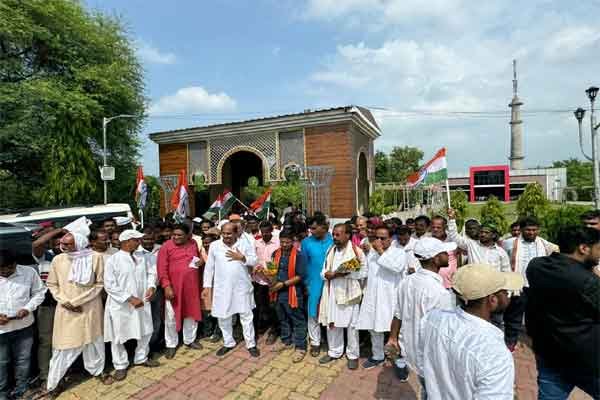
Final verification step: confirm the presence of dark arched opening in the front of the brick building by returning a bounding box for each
[221,150,264,201]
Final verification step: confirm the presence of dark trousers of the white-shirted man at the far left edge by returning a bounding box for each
[0,326,33,399]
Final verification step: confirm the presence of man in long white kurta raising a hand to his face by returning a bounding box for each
[358,226,407,369]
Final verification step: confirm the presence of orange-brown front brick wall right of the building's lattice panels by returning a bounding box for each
[305,124,356,218]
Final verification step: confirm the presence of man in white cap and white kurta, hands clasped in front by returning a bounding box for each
[104,229,159,381]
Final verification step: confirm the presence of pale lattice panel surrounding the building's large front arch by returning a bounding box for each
[209,132,280,184]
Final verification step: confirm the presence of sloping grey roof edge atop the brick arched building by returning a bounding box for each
[150,105,381,143]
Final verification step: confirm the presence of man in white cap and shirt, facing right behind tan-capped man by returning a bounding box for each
[388,237,456,390]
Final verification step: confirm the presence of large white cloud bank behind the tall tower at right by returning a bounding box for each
[305,0,600,171]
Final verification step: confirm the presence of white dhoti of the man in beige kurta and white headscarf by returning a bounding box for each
[46,336,105,391]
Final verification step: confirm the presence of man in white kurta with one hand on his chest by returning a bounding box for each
[204,223,259,357]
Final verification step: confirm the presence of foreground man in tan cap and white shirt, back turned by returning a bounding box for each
[417,264,524,400]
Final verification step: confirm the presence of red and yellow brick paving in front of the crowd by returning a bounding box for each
[51,332,591,400]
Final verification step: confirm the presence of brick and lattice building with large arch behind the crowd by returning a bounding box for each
[150,106,381,218]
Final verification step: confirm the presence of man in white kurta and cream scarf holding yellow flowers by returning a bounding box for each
[319,224,366,369]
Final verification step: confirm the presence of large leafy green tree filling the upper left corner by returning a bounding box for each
[0,0,145,207]
